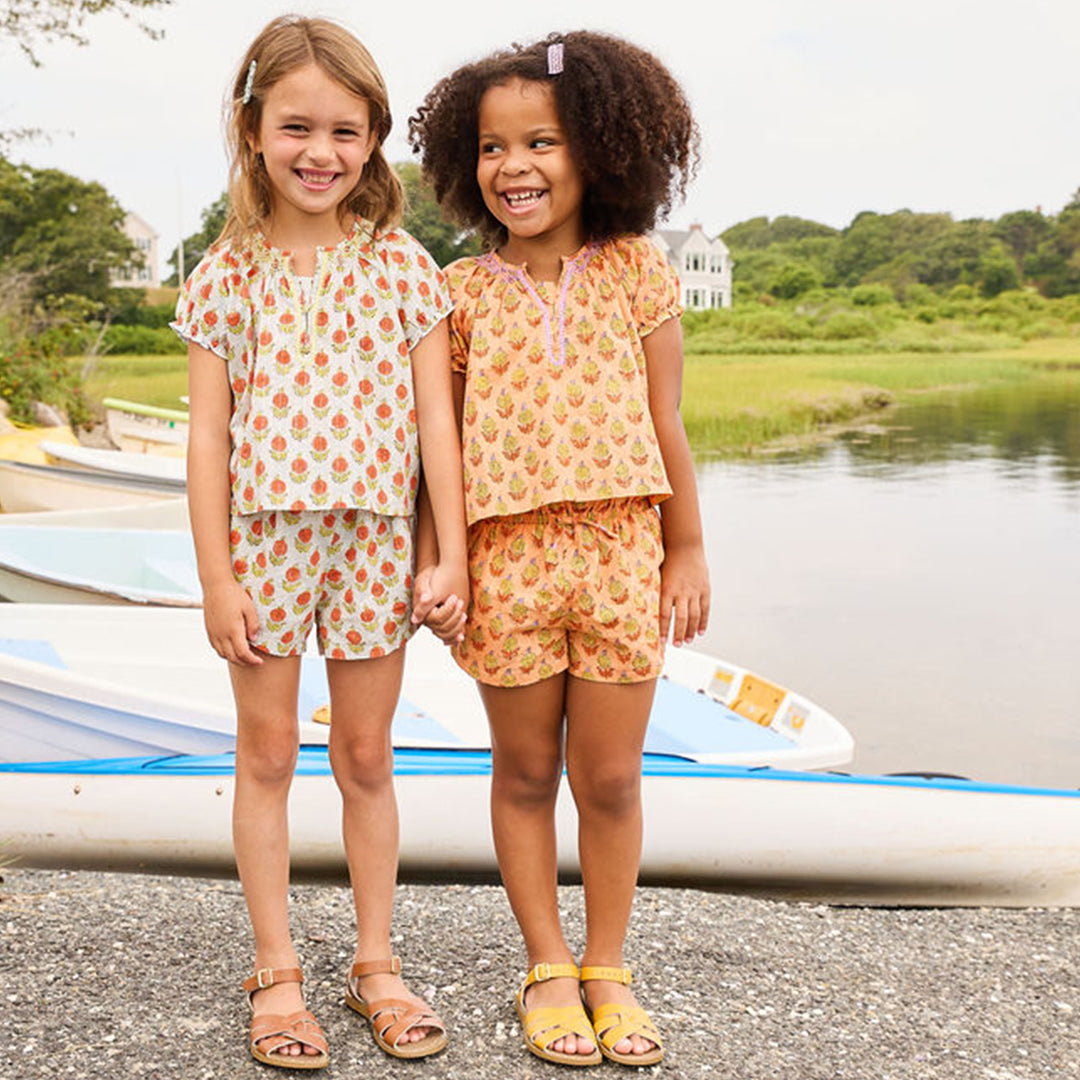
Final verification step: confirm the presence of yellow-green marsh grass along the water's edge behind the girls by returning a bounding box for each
[76,338,1080,455]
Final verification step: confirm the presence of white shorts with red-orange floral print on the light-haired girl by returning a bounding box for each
[229,510,413,660]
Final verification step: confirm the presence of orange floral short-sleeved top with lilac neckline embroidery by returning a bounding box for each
[446,237,683,524]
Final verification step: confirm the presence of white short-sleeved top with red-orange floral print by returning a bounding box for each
[172,221,449,516]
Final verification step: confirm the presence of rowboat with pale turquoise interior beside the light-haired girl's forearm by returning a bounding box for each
[0,524,202,607]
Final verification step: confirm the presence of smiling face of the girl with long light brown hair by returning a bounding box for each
[252,64,376,238]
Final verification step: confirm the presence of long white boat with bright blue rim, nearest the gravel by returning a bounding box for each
[0,746,1080,907]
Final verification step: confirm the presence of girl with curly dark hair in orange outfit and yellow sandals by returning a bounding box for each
[410,31,708,1065]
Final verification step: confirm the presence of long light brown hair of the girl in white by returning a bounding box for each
[218,15,404,243]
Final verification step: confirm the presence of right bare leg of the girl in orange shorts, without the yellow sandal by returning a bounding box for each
[566,676,656,1054]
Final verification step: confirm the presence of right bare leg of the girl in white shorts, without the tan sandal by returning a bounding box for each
[326,648,431,1042]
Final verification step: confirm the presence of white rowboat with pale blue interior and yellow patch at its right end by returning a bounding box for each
[0,604,853,768]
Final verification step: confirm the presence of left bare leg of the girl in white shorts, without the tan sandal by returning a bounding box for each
[229,656,316,1055]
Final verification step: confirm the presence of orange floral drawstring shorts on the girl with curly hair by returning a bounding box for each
[454,499,663,687]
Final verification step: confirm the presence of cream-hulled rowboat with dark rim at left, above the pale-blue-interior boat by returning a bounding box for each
[0,461,184,513]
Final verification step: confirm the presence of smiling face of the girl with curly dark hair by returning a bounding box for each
[476,79,585,261]
